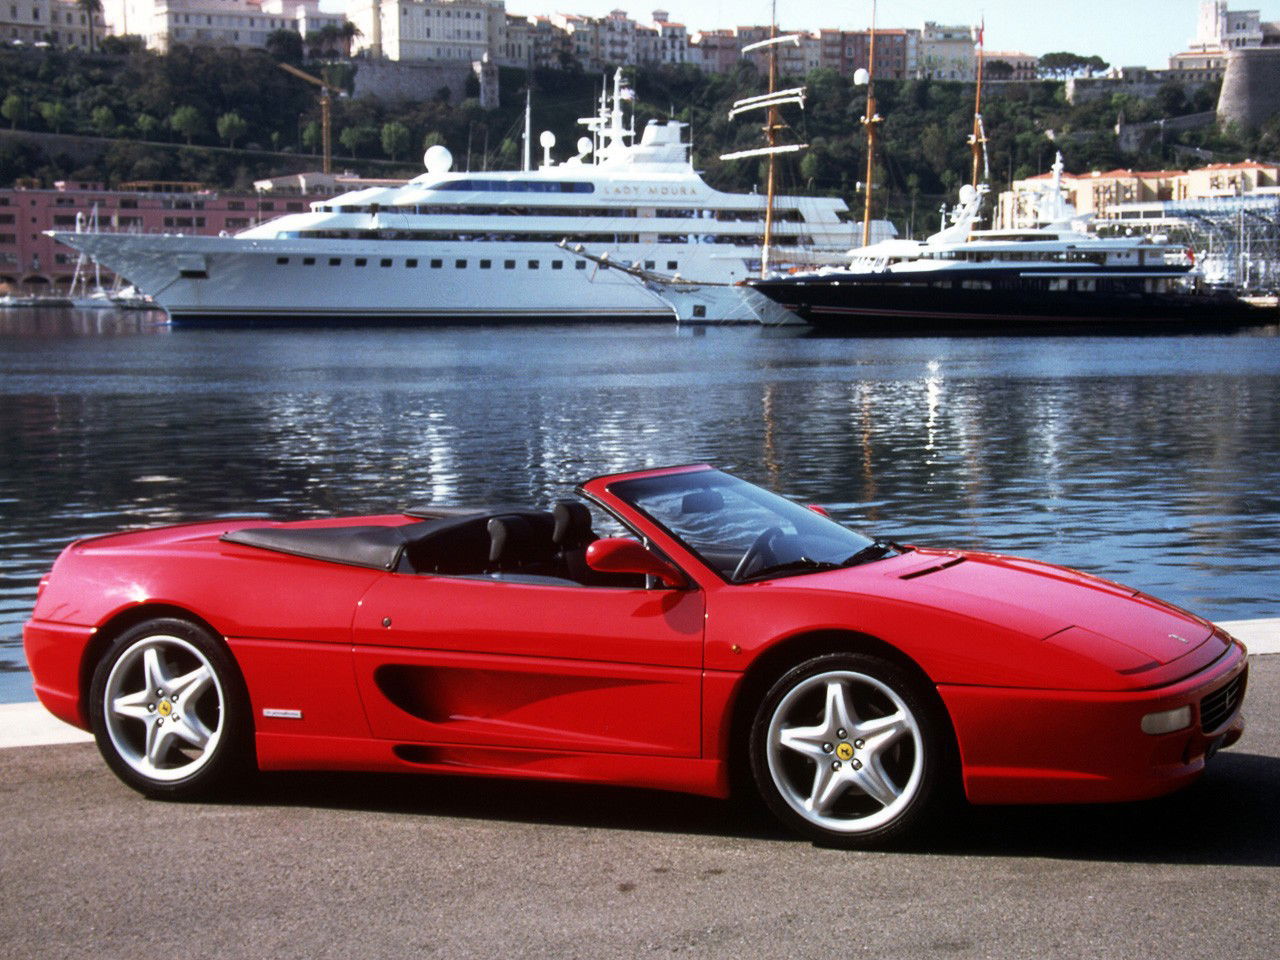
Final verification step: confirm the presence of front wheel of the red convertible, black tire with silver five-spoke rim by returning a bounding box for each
[749,653,954,849]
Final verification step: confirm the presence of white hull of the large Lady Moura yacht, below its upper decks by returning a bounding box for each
[56,233,748,325]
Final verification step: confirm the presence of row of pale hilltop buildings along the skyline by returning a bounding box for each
[0,0,1280,82]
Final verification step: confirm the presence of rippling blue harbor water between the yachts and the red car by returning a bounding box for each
[0,310,1280,701]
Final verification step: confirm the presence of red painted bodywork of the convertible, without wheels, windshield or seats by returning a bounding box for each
[24,466,1247,834]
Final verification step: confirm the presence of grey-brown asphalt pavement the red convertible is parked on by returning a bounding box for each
[0,657,1280,960]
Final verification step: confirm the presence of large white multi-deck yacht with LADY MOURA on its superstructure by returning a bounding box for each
[54,72,854,324]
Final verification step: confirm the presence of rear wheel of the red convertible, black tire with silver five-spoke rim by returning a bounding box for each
[90,617,256,800]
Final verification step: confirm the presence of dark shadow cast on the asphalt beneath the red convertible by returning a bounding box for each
[241,753,1280,867]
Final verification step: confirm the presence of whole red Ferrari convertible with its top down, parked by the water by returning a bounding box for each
[24,466,1247,846]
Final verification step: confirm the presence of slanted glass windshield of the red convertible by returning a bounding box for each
[609,470,891,582]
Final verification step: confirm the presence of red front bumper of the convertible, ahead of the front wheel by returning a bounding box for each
[938,641,1248,804]
